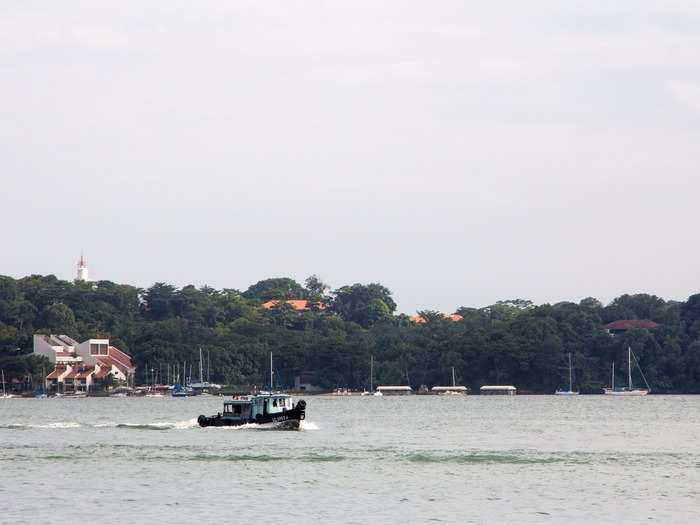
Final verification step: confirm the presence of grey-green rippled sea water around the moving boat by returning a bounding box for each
[0,396,700,525]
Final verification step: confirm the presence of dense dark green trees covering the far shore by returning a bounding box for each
[0,275,700,393]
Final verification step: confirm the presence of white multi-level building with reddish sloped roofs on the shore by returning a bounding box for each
[34,334,136,392]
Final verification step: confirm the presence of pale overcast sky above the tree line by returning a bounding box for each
[0,0,700,313]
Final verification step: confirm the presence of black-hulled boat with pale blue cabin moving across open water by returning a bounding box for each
[197,392,306,430]
